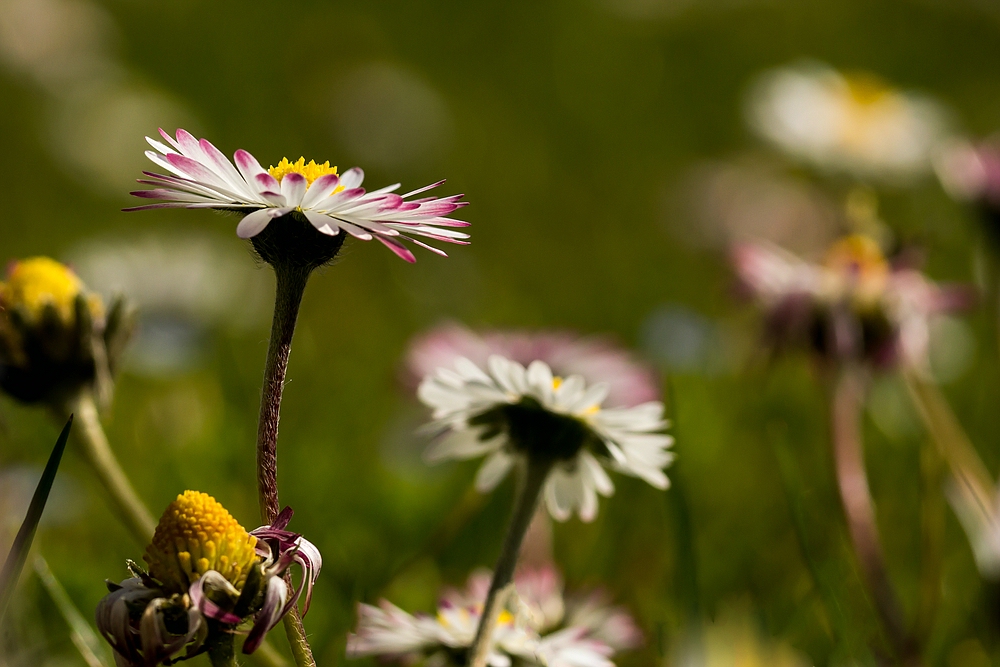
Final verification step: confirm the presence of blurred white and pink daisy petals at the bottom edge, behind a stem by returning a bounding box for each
[347,566,642,667]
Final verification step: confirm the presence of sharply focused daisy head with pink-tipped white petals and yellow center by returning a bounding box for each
[127,130,468,262]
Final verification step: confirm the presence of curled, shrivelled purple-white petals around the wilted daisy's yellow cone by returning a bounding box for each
[97,508,323,667]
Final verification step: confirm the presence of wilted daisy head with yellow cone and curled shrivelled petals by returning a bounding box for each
[97,491,322,667]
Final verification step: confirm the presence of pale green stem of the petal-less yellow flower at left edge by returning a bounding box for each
[59,389,156,547]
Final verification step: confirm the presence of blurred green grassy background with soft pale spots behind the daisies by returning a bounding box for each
[0,0,1000,667]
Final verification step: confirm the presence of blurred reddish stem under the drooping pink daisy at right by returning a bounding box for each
[831,364,919,665]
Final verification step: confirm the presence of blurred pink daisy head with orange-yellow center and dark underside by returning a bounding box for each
[733,235,969,371]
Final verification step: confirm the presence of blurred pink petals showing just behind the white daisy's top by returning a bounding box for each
[406,322,660,407]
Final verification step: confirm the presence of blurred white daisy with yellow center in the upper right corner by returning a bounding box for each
[747,64,948,179]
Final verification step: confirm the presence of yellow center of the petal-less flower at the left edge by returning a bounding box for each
[0,257,83,322]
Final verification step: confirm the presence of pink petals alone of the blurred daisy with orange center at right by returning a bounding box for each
[732,237,970,371]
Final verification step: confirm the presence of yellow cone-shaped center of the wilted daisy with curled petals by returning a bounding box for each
[143,491,257,592]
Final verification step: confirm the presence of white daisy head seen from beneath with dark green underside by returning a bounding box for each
[417,355,673,521]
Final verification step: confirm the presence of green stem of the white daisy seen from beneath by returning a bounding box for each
[469,457,555,667]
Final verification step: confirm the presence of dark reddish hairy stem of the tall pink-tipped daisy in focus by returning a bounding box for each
[257,263,316,667]
